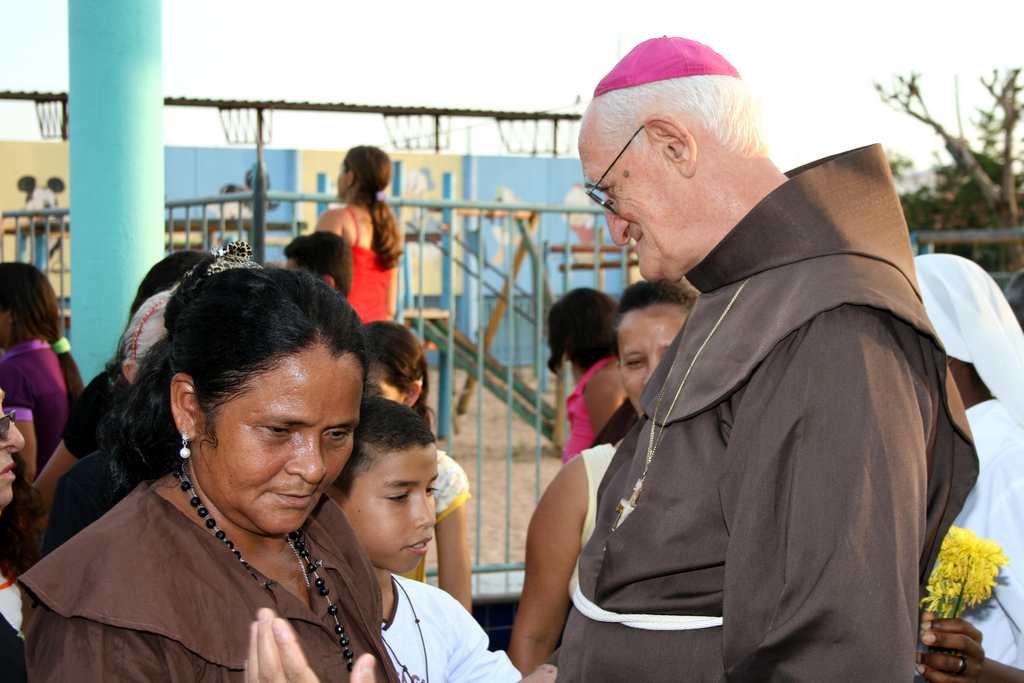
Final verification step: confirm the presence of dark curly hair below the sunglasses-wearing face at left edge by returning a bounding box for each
[0,453,43,580]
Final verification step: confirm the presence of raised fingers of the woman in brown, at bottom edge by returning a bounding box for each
[246,607,375,683]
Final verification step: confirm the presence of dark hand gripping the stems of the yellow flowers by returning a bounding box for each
[918,612,985,683]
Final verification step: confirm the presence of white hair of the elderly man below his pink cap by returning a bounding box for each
[584,76,768,157]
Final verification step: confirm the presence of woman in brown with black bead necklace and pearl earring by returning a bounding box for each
[22,245,396,681]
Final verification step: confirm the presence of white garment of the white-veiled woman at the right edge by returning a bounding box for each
[953,399,1024,669]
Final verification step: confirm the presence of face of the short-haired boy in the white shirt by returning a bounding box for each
[337,444,437,573]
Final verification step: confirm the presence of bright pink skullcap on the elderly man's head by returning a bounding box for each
[594,36,739,97]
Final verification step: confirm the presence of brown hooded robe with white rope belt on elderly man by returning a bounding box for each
[552,145,978,683]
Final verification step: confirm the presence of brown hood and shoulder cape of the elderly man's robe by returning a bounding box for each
[622,144,978,595]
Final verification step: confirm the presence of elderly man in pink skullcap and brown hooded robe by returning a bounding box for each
[547,38,978,683]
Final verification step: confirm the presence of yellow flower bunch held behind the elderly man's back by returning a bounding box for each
[921,526,1010,618]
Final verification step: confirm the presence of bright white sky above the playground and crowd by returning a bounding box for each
[0,0,1024,169]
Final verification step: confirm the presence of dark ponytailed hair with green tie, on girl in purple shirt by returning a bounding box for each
[0,263,85,405]
